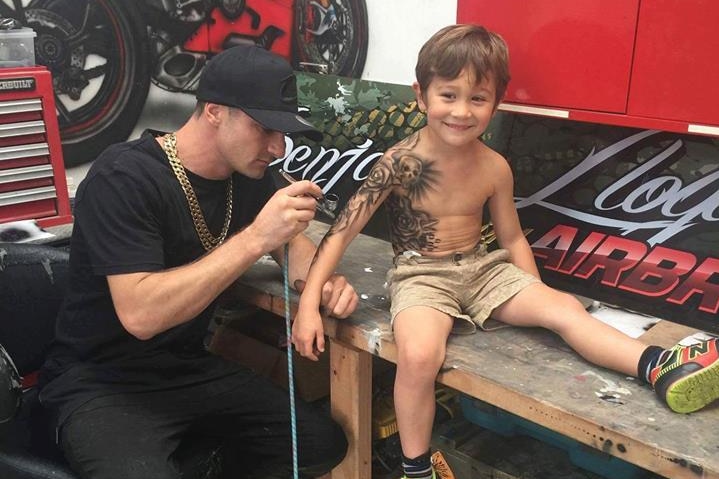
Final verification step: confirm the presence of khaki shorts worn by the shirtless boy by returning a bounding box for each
[387,245,539,334]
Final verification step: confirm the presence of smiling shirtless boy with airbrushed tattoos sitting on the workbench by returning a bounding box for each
[292,25,719,478]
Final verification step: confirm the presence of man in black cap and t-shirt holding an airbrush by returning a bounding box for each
[41,46,358,479]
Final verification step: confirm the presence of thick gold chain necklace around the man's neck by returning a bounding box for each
[162,133,232,251]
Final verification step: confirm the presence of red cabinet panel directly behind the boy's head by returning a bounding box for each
[457,0,640,113]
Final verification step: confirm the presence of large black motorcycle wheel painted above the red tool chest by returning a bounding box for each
[5,0,150,167]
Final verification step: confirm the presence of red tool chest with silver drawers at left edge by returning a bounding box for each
[0,67,72,227]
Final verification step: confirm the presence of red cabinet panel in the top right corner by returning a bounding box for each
[629,0,719,125]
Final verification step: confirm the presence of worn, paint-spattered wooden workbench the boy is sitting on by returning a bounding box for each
[228,223,719,479]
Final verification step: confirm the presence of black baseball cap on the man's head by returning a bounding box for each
[195,45,322,141]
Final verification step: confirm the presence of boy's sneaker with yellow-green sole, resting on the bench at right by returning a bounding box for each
[649,338,719,413]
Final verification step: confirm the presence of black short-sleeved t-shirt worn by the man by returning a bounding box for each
[41,131,275,421]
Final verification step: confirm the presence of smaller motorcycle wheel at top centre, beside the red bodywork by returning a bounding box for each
[292,0,368,78]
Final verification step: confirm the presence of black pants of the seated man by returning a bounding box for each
[60,370,347,479]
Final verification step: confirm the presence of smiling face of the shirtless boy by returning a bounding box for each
[414,69,496,147]
